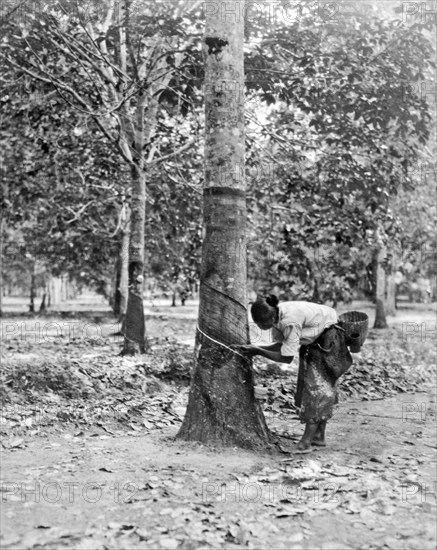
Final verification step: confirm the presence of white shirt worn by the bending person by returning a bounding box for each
[272,302,338,357]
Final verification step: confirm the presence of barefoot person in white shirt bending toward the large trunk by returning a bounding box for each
[240,295,352,453]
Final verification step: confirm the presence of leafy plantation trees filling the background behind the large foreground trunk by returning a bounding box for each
[0,0,436,336]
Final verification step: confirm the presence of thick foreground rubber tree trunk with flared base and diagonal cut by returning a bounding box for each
[178,2,269,448]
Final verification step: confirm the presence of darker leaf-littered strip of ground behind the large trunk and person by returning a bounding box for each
[0,320,436,444]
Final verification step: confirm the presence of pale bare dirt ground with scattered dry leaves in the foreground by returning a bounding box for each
[0,303,437,550]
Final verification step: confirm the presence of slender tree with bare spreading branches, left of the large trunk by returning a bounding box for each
[2,0,202,354]
